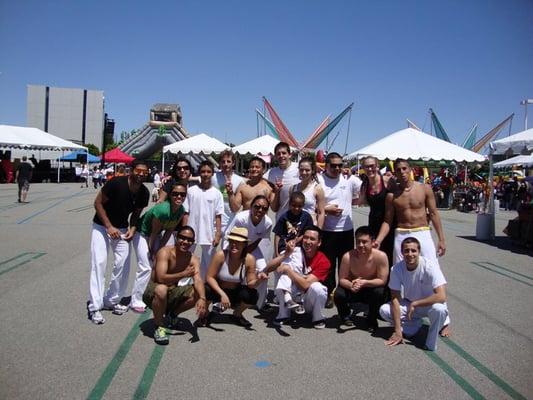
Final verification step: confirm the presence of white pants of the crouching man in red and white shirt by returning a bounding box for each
[275,280,328,322]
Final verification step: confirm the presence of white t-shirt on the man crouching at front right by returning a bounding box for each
[389,257,446,301]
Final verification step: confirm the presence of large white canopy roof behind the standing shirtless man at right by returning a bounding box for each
[345,128,486,162]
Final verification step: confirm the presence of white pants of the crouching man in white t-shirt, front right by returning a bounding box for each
[379,299,450,350]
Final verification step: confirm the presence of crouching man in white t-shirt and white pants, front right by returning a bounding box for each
[379,237,450,351]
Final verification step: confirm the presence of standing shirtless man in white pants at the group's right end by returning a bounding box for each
[374,158,446,266]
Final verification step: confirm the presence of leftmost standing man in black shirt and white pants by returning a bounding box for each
[87,161,150,324]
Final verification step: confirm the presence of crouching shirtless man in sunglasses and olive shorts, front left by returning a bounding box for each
[143,226,207,344]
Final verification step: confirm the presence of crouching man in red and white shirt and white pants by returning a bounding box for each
[265,226,331,329]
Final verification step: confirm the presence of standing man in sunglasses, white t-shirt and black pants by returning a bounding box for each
[320,152,361,308]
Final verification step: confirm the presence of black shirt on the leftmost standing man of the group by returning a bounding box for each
[93,176,150,228]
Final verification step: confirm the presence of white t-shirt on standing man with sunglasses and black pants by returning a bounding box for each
[322,173,361,232]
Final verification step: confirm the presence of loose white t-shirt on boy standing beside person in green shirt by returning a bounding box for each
[187,186,224,244]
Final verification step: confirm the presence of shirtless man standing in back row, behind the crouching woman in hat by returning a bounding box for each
[226,157,274,213]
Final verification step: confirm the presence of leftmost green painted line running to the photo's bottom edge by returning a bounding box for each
[87,312,152,400]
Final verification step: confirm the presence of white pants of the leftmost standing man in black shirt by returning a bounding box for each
[88,223,130,311]
